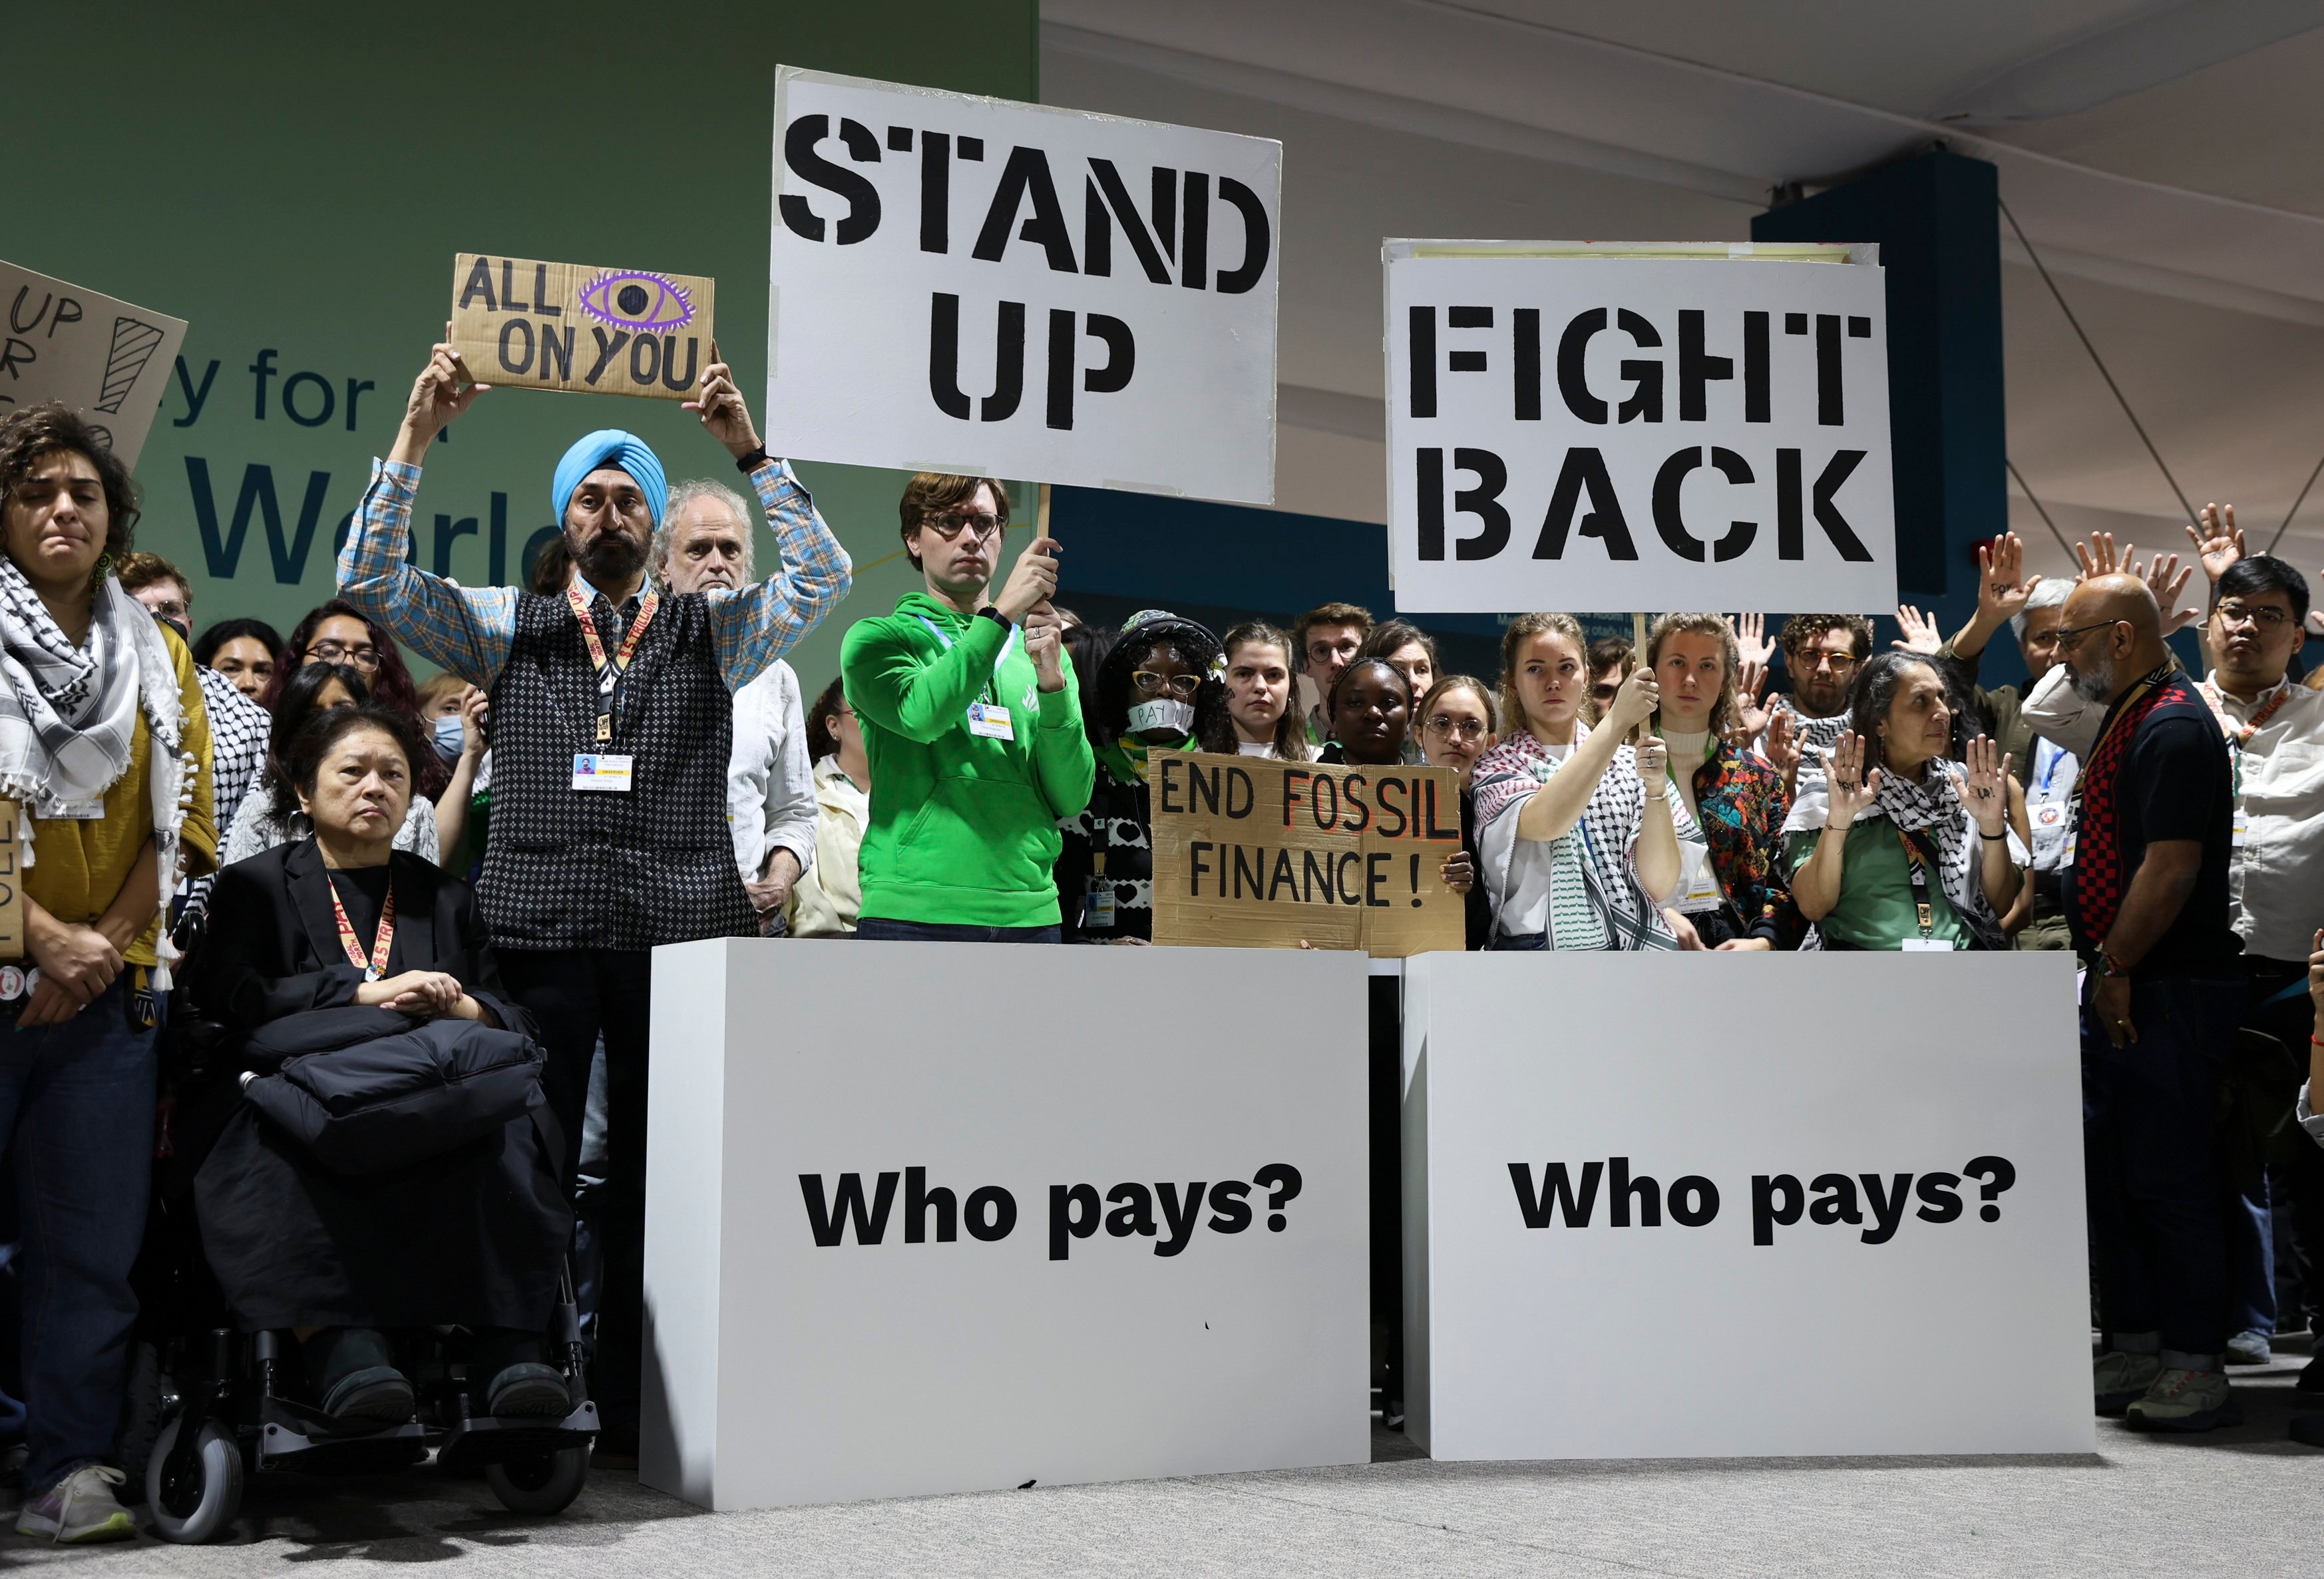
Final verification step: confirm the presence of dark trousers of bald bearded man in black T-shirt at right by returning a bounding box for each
[2082,977,2245,1365]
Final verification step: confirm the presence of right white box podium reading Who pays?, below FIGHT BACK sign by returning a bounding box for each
[1404,953,2096,1458]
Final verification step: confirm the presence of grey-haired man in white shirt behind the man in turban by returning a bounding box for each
[653,479,816,933]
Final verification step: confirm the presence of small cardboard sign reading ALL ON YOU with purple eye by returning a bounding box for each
[451,251,718,400]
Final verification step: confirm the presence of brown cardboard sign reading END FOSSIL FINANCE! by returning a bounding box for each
[1146,751,1466,958]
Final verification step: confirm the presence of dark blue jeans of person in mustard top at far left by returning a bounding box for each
[0,972,158,1495]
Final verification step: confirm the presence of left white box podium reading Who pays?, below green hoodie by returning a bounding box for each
[639,939,1371,1509]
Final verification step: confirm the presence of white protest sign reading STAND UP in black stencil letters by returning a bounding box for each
[767,65,1283,505]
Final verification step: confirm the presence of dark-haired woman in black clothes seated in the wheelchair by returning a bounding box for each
[190,704,572,1423]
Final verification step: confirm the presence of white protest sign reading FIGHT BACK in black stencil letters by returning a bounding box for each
[1385,242,1896,614]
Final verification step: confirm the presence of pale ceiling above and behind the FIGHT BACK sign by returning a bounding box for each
[1041,0,2324,586]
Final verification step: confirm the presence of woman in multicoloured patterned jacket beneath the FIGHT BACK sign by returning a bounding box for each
[1645,614,1796,949]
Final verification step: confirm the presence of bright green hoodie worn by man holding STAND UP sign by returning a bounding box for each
[839,593,1097,925]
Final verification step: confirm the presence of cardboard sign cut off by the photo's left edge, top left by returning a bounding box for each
[0,263,186,470]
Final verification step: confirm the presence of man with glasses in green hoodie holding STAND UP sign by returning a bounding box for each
[839,472,1097,944]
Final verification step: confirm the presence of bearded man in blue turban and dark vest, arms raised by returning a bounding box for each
[339,326,853,1453]
